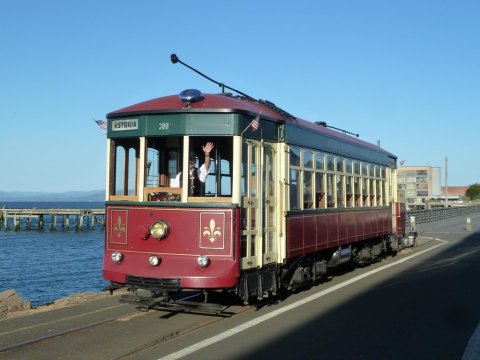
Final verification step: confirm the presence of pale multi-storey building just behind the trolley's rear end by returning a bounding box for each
[397,166,442,210]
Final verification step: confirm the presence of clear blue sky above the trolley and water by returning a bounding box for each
[0,0,480,192]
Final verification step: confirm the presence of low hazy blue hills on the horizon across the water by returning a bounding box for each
[0,190,105,202]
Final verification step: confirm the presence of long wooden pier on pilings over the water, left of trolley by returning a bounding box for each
[0,209,105,231]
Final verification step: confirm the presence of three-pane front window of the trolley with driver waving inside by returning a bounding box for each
[108,136,233,201]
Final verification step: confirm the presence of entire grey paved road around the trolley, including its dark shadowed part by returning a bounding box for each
[0,214,480,360]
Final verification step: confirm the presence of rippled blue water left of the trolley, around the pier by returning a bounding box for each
[0,202,108,306]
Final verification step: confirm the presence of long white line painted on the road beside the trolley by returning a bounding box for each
[159,237,448,360]
